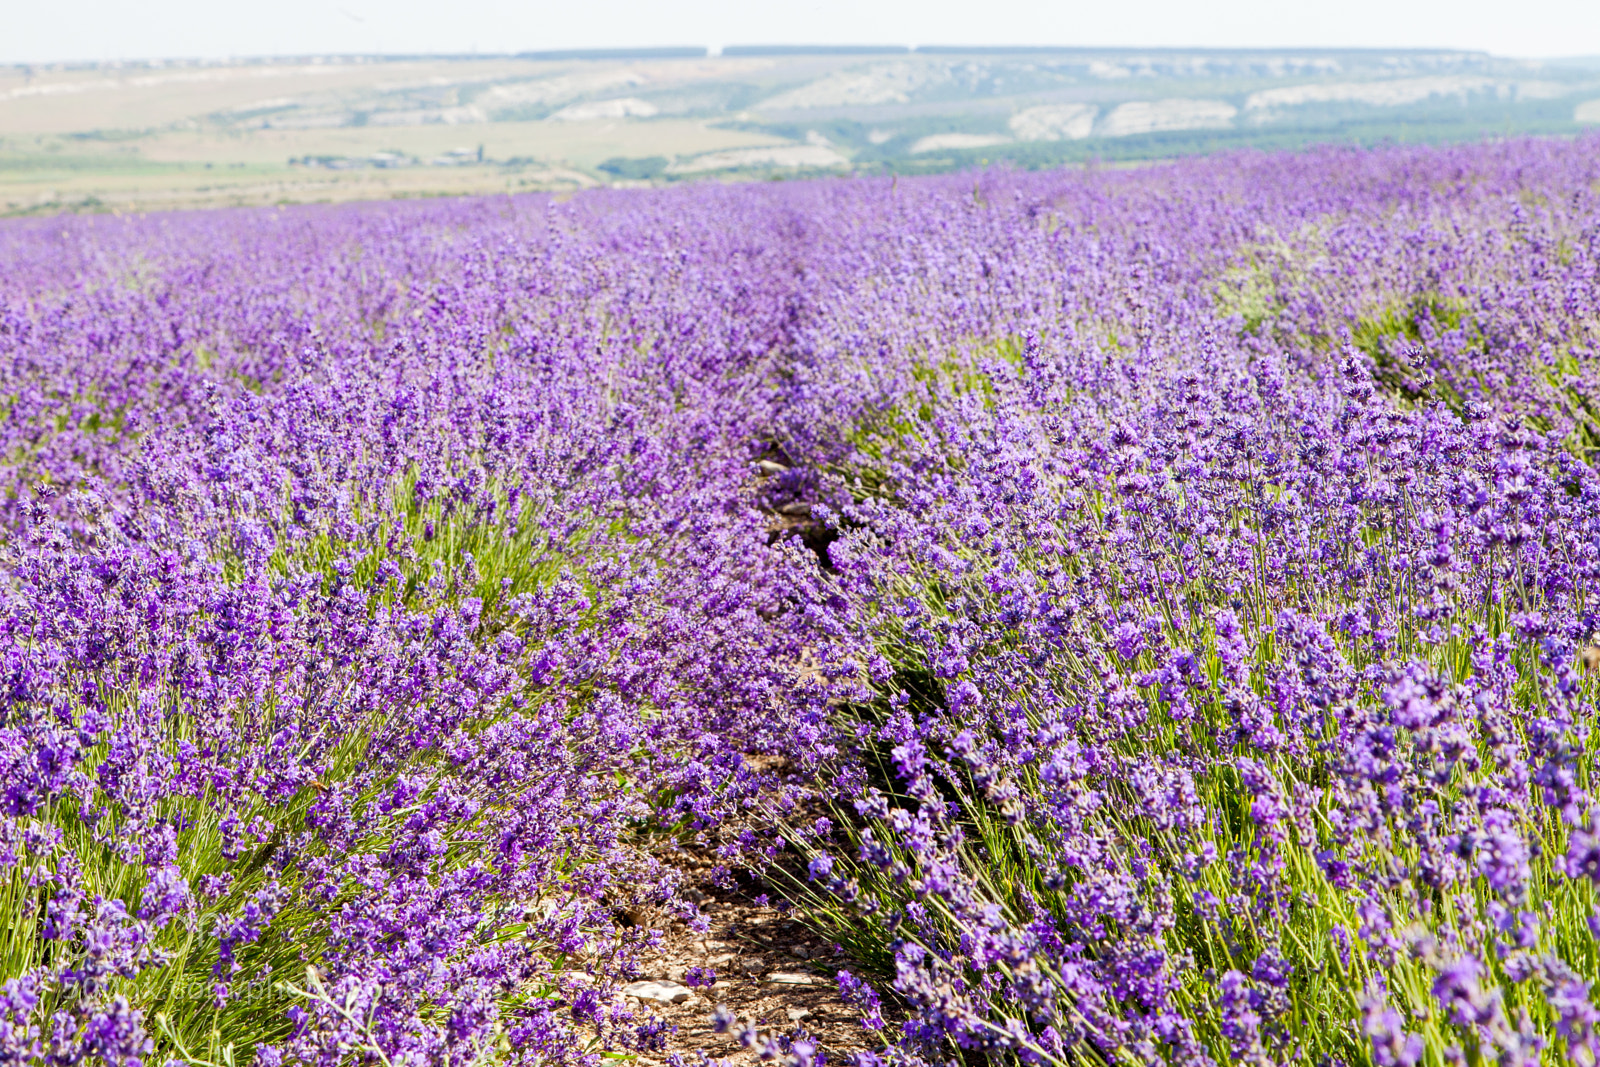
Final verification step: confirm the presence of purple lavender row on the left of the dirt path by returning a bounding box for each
[0,198,814,1064]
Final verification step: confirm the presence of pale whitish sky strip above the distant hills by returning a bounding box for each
[0,0,1600,62]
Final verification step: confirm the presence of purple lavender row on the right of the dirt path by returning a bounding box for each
[781,141,1600,1064]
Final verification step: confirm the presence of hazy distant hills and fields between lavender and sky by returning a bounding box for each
[0,48,1600,214]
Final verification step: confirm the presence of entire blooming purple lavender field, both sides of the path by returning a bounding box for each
[0,138,1600,1067]
